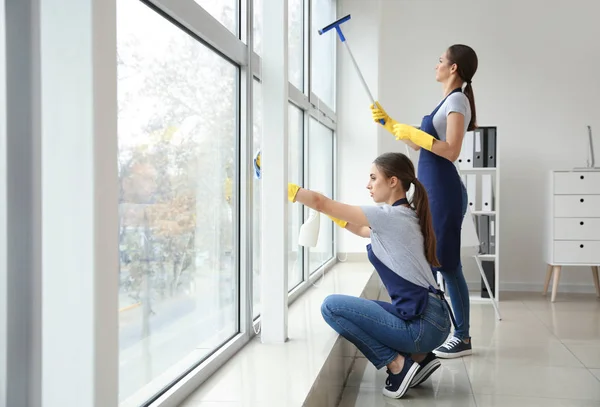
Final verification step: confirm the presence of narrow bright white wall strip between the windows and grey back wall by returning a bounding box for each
[332,0,382,253]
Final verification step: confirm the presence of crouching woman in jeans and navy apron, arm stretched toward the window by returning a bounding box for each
[288,153,451,398]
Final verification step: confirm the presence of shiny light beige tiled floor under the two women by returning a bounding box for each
[340,293,600,407]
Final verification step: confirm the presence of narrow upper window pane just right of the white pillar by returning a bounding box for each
[288,0,304,91]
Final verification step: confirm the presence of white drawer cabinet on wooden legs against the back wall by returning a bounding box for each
[544,170,600,301]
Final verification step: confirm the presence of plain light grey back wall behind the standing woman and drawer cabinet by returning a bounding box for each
[339,0,600,291]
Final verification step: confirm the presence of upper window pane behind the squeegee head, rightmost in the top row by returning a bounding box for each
[310,0,338,109]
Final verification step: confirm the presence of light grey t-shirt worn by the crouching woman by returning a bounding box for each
[361,204,438,288]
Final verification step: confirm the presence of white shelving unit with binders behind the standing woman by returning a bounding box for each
[455,126,501,319]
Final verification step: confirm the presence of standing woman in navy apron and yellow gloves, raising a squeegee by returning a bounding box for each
[371,44,478,358]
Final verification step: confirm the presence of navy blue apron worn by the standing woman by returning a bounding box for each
[418,88,463,271]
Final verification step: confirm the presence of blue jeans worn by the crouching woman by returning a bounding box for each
[321,294,451,369]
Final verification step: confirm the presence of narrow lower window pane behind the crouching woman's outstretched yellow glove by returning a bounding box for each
[288,104,304,290]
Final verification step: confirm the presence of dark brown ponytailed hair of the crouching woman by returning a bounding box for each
[373,153,440,267]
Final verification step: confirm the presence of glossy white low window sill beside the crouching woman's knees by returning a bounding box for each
[177,262,380,407]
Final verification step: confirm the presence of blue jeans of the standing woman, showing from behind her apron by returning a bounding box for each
[440,183,471,339]
